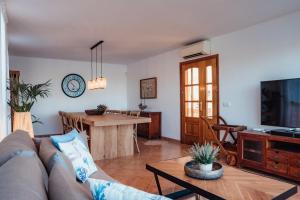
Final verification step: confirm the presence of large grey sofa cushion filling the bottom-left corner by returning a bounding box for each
[0,154,47,200]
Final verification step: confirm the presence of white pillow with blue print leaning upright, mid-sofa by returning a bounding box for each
[58,137,97,182]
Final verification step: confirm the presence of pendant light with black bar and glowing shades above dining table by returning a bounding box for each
[88,41,107,90]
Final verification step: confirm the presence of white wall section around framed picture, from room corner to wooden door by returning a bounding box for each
[127,50,180,139]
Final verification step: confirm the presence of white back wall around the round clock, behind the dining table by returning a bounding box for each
[10,56,127,134]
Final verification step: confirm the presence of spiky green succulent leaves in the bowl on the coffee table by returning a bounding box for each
[190,143,220,165]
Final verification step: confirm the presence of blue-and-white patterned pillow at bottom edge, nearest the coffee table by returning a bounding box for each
[88,178,170,200]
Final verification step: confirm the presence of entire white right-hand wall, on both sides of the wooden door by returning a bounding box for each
[127,12,300,139]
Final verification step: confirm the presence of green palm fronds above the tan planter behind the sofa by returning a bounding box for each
[7,80,51,122]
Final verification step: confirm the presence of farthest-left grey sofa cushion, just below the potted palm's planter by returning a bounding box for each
[0,131,36,166]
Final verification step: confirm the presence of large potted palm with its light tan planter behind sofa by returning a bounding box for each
[7,80,51,137]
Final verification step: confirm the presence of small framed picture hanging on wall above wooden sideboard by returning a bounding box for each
[140,77,157,99]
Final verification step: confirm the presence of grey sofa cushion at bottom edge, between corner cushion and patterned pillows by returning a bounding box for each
[48,164,92,200]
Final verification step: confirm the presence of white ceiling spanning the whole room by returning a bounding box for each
[6,0,300,64]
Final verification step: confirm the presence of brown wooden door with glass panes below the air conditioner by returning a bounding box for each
[180,55,219,144]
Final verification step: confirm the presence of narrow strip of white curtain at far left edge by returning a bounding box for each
[0,3,9,141]
